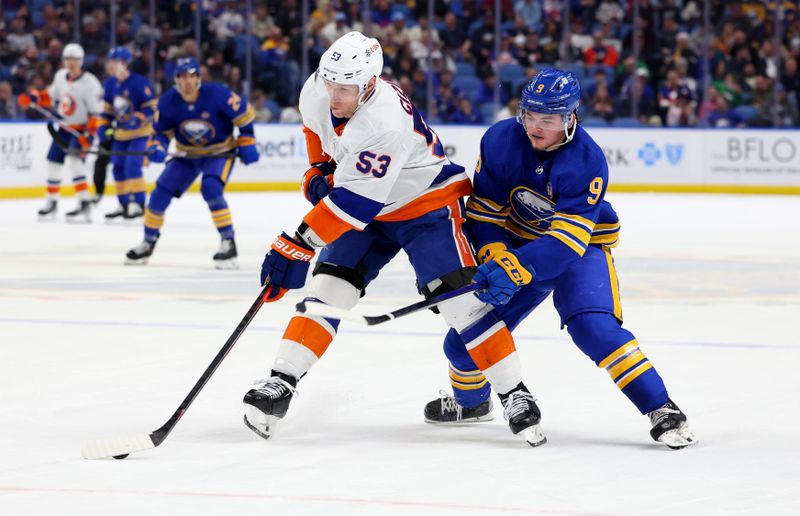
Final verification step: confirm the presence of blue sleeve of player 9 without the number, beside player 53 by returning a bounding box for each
[467,135,510,249]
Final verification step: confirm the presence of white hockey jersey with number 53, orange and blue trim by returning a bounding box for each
[300,74,471,243]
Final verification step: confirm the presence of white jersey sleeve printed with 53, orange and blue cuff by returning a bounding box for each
[304,130,409,244]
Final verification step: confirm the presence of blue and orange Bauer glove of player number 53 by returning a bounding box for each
[261,233,315,303]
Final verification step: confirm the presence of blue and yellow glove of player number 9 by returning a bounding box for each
[472,250,534,305]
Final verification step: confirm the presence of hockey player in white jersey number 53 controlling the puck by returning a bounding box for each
[244,32,544,446]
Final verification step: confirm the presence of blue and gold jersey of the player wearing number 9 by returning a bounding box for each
[467,118,619,280]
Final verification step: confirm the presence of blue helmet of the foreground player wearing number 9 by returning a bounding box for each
[519,68,581,115]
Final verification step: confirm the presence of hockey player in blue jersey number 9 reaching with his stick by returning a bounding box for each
[425,70,696,448]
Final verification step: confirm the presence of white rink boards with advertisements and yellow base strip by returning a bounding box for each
[0,122,800,198]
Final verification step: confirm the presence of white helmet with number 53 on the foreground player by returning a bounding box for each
[317,31,383,95]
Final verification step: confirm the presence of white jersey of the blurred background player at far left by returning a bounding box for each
[47,68,103,126]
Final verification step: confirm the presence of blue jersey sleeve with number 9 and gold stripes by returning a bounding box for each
[517,153,608,280]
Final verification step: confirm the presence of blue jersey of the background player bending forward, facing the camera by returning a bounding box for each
[155,83,255,156]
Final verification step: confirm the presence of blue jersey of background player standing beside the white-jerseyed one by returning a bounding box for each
[102,73,157,141]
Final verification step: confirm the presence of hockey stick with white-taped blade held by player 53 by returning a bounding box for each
[81,278,272,459]
